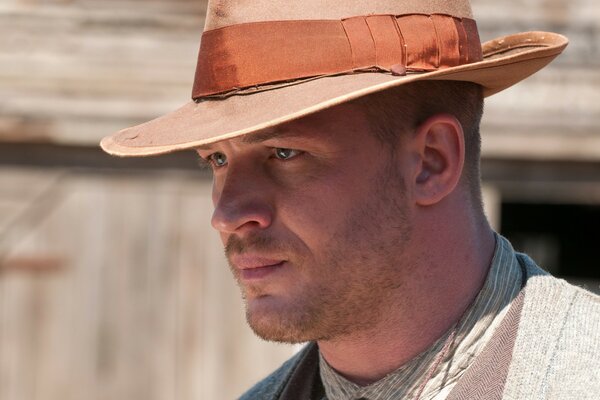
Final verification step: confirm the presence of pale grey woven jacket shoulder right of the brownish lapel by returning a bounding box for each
[504,255,600,399]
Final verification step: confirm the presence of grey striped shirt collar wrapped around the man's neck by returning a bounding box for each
[319,235,522,400]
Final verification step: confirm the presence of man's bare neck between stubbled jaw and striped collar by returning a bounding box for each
[318,212,495,385]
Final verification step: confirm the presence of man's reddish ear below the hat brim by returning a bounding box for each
[411,114,465,206]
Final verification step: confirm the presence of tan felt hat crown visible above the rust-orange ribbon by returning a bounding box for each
[204,0,472,31]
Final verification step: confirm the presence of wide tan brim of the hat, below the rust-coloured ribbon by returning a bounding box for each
[100,32,568,157]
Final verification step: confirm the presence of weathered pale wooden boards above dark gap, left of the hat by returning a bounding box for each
[0,0,206,146]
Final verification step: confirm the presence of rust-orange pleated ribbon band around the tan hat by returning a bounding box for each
[192,14,482,99]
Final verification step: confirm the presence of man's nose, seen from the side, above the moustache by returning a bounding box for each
[211,170,273,234]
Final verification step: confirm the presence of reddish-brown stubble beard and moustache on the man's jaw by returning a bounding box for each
[226,159,412,343]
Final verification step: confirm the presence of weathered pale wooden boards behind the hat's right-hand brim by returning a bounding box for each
[472,0,600,162]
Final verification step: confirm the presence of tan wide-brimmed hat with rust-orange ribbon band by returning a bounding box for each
[101,0,568,156]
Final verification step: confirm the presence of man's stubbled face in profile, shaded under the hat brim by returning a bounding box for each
[198,105,411,342]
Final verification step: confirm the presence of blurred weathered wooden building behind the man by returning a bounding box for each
[0,0,600,400]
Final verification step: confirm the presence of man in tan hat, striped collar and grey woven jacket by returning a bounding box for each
[102,0,600,400]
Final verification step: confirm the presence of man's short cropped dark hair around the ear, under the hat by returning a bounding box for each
[354,80,483,206]
